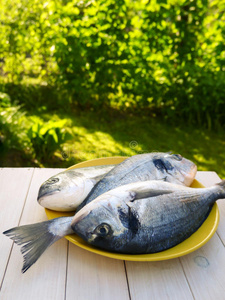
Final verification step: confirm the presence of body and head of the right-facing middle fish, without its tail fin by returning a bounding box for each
[77,152,197,211]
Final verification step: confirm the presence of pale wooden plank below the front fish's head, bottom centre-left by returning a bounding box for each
[66,244,129,300]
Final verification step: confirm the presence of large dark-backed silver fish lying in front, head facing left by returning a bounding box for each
[71,180,225,254]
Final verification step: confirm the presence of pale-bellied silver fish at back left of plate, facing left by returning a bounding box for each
[37,165,115,211]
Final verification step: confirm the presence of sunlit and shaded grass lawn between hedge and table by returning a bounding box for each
[0,111,225,178]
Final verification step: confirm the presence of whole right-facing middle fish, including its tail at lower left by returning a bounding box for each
[3,153,197,272]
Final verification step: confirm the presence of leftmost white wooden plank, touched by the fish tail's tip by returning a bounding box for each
[0,168,33,283]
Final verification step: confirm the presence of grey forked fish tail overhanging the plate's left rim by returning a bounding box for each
[3,217,73,273]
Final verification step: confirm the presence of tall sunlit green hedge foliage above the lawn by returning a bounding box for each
[0,0,225,128]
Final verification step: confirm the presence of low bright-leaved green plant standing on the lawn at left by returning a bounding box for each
[27,117,72,160]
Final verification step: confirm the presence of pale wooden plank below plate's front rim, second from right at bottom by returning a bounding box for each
[126,259,193,300]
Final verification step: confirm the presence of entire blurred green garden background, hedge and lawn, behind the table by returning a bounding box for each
[0,0,225,177]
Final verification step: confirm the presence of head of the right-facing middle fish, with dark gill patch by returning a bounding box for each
[153,153,197,186]
